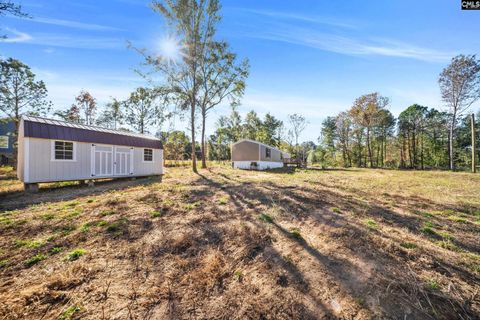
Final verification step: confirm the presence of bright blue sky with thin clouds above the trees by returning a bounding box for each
[0,0,480,141]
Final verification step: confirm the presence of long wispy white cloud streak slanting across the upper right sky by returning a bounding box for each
[235,8,454,62]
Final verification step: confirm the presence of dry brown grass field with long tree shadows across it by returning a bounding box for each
[0,166,480,319]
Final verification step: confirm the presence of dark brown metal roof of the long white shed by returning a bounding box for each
[23,116,163,149]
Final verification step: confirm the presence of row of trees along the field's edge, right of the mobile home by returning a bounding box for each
[309,55,480,170]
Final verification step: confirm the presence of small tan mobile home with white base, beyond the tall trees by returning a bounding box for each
[232,139,290,170]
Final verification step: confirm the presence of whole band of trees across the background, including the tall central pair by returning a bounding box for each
[0,0,480,171]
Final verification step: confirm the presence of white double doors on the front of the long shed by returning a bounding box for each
[92,144,133,177]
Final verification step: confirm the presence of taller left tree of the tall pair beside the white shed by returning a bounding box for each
[137,0,224,172]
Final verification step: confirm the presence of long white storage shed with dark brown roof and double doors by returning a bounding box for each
[17,116,163,189]
